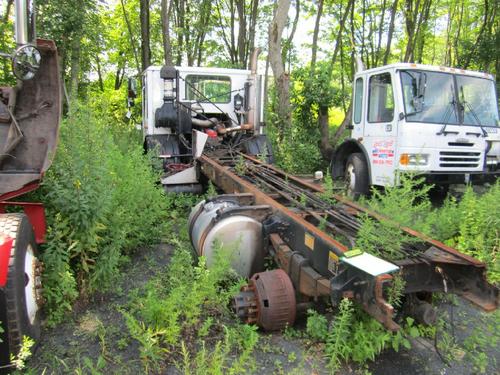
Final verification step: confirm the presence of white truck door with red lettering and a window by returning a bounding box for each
[363,72,397,186]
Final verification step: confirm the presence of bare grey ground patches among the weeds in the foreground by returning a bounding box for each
[27,245,500,375]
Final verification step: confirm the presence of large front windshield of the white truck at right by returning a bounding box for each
[401,70,498,126]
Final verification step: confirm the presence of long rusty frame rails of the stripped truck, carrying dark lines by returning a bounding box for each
[198,150,498,330]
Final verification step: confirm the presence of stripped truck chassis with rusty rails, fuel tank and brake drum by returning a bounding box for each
[190,149,498,330]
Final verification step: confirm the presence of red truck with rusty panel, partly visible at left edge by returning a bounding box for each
[0,0,61,366]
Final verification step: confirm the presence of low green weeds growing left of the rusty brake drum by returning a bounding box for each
[124,231,254,374]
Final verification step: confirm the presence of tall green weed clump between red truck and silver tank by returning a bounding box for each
[40,106,166,323]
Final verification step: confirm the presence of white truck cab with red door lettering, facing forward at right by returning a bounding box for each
[332,63,500,196]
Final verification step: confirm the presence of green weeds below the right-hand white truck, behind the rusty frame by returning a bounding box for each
[356,175,500,282]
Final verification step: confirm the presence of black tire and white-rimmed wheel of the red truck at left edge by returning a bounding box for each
[0,214,41,363]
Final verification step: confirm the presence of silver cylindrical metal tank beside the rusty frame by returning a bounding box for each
[188,200,264,278]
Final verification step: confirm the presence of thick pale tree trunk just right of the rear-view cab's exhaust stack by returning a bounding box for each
[269,0,291,141]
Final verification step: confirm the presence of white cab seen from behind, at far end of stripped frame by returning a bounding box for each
[139,51,272,193]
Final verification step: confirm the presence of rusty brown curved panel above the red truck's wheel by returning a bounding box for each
[0,39,62,199]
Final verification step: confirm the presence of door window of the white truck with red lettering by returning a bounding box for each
[368,73,394,122]
